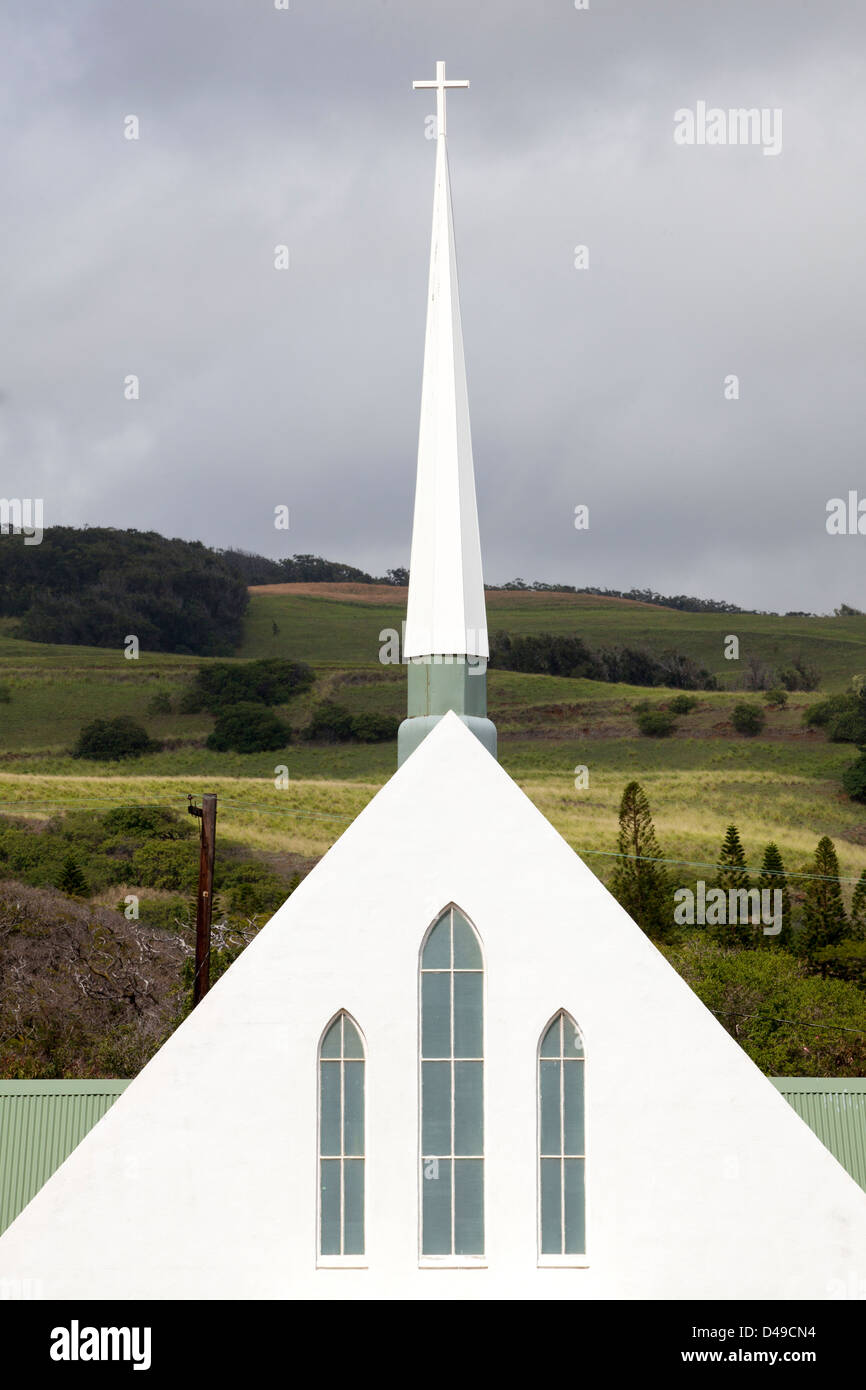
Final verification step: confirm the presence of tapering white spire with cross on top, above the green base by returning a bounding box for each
[403,63,488,657]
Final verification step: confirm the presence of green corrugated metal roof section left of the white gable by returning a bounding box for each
[0,1080,129,1232]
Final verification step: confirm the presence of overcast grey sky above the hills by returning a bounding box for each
[0,0,866,612]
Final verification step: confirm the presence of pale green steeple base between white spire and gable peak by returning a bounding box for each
[398,656,496,767]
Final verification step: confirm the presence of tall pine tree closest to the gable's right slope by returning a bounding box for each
[610,781,673,937]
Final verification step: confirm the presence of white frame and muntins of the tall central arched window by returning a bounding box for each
[417,902,488,1269]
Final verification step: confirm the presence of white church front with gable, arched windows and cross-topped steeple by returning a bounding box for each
[0,64,866,1300]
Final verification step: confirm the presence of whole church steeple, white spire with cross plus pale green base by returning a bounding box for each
[398,63,496,763]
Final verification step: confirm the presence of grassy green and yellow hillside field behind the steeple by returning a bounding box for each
[0,592,866,877]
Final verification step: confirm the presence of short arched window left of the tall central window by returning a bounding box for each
[318,1013,364,1257]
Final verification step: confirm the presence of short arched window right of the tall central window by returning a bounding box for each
[538,1009,587,1257]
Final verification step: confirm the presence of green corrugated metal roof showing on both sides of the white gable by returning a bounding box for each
[0,1076,866,1232]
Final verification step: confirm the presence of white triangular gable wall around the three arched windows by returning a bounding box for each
[0,714,866,1298]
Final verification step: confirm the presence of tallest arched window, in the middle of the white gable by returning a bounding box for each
[421,906,484,1257]
